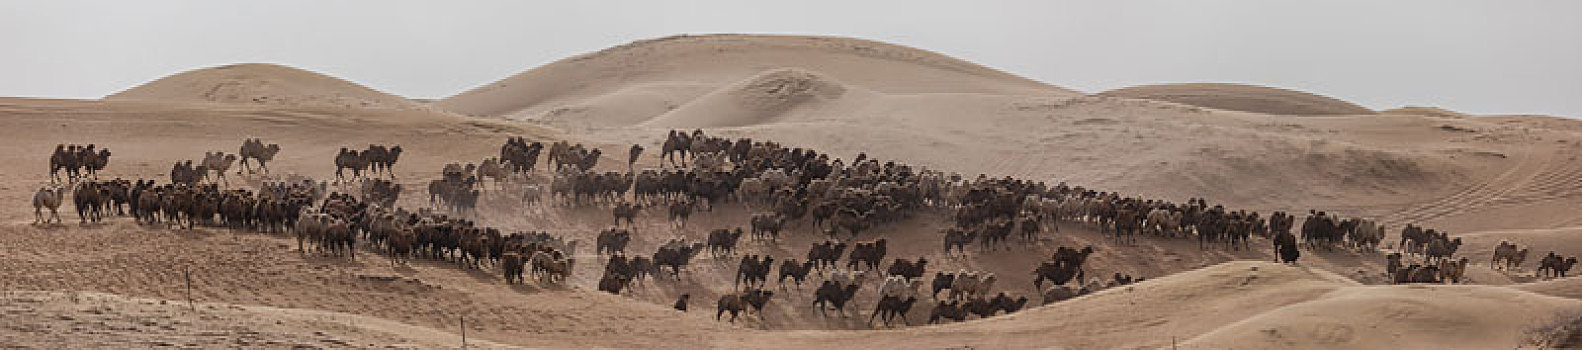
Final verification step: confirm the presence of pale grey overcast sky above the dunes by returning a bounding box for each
[0,0,1582,117]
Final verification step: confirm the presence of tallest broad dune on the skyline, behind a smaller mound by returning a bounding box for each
[437,35,1079,125]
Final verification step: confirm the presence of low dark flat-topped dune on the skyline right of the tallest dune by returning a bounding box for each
[1099,82,1373,116]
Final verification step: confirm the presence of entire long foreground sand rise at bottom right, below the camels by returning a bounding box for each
[724,261,1582,348]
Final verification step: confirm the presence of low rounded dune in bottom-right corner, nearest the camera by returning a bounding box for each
[1182,285,1582,348]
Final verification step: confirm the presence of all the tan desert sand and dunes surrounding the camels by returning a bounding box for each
[0,35,1582,348]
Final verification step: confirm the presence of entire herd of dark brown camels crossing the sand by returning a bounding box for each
[33,130,1577,325]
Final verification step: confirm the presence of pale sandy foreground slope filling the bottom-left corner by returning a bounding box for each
[0,291,516,348]
